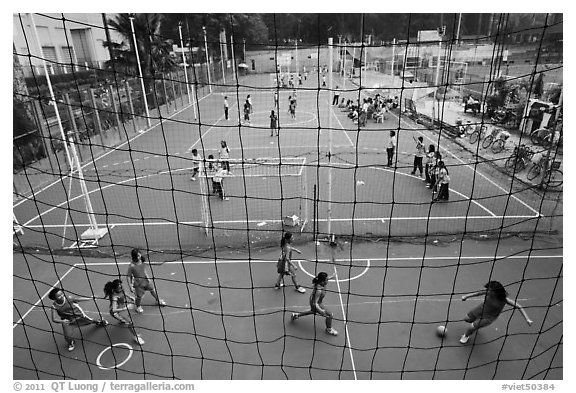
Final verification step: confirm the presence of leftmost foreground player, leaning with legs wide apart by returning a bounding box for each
[48,288,108,351]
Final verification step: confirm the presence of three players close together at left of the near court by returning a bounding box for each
[48,248,166,351]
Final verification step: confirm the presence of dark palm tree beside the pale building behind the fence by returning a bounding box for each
[108,13,176,107]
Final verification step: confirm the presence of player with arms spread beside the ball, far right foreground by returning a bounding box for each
[460,281,533,344]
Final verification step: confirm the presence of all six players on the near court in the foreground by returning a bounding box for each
[48,239,533,351]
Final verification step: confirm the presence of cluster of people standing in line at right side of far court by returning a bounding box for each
[410,136,450,202]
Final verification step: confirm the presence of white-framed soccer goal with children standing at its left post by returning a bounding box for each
[199,157,309,235]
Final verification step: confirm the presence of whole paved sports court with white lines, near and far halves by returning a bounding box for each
[13,13,563,380]
